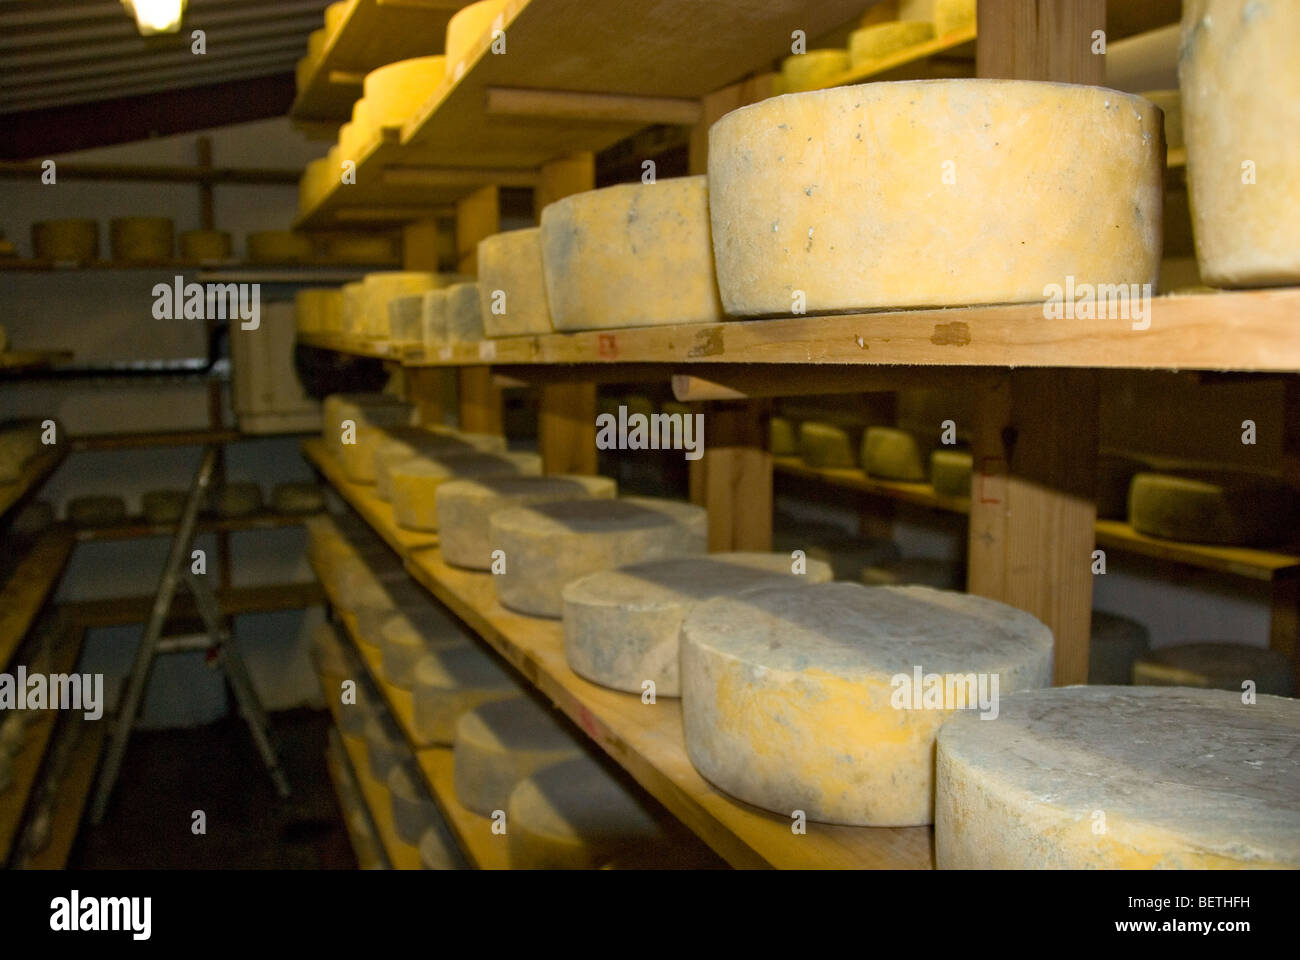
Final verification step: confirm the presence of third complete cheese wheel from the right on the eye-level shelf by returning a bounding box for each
[477,226,553,337]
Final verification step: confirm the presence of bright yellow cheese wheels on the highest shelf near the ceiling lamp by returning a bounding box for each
[298,0,506,212]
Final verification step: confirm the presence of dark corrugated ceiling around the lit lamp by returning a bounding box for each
[0,0,329,114]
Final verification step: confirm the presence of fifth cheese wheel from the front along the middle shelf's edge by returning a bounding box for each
[434,475,618,570]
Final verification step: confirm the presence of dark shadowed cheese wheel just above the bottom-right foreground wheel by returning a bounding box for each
[1132,643,1295,697]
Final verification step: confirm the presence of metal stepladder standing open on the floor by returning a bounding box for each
[91,446,289,825]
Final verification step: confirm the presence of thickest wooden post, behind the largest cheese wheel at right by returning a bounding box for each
[969,0,1106,684]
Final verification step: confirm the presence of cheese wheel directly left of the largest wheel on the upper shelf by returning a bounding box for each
[541,176,723,330]
